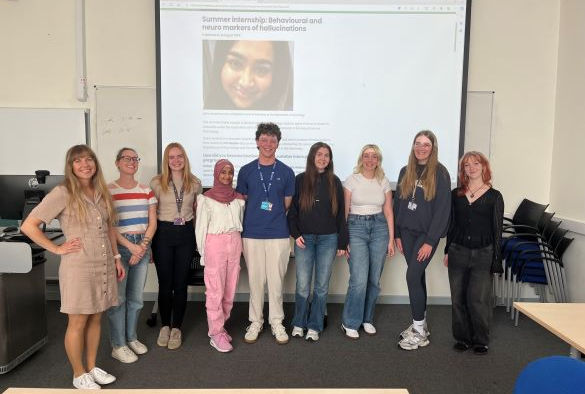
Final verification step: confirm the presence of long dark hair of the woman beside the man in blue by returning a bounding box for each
[299,142,339,216]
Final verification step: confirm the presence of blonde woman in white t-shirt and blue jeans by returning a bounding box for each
[341,144,394,339]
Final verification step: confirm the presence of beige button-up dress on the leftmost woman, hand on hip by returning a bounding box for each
[30,186,118,314]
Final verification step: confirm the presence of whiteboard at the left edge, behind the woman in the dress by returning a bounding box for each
[0,108,87,175]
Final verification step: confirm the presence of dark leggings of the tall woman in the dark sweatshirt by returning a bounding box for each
[400,228,437,321]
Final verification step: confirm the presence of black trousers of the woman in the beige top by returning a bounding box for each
[152,221,195,328]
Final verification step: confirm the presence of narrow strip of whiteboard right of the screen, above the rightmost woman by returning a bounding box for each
[465,91,494,158]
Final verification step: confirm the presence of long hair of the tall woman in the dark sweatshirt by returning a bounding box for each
[400,130,439,201]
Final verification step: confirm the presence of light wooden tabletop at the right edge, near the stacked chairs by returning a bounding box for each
[514,302,585,358]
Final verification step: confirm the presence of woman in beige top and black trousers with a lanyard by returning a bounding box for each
[150,142,201,350]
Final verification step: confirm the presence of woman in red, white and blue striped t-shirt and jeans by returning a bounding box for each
[108,148,156,363]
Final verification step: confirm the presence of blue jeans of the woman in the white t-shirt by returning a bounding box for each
[341,213,390,330]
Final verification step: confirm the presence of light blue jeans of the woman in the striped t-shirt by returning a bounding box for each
[108,234,150,347]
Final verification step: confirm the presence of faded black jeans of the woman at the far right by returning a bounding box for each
[448,244,494,346]
